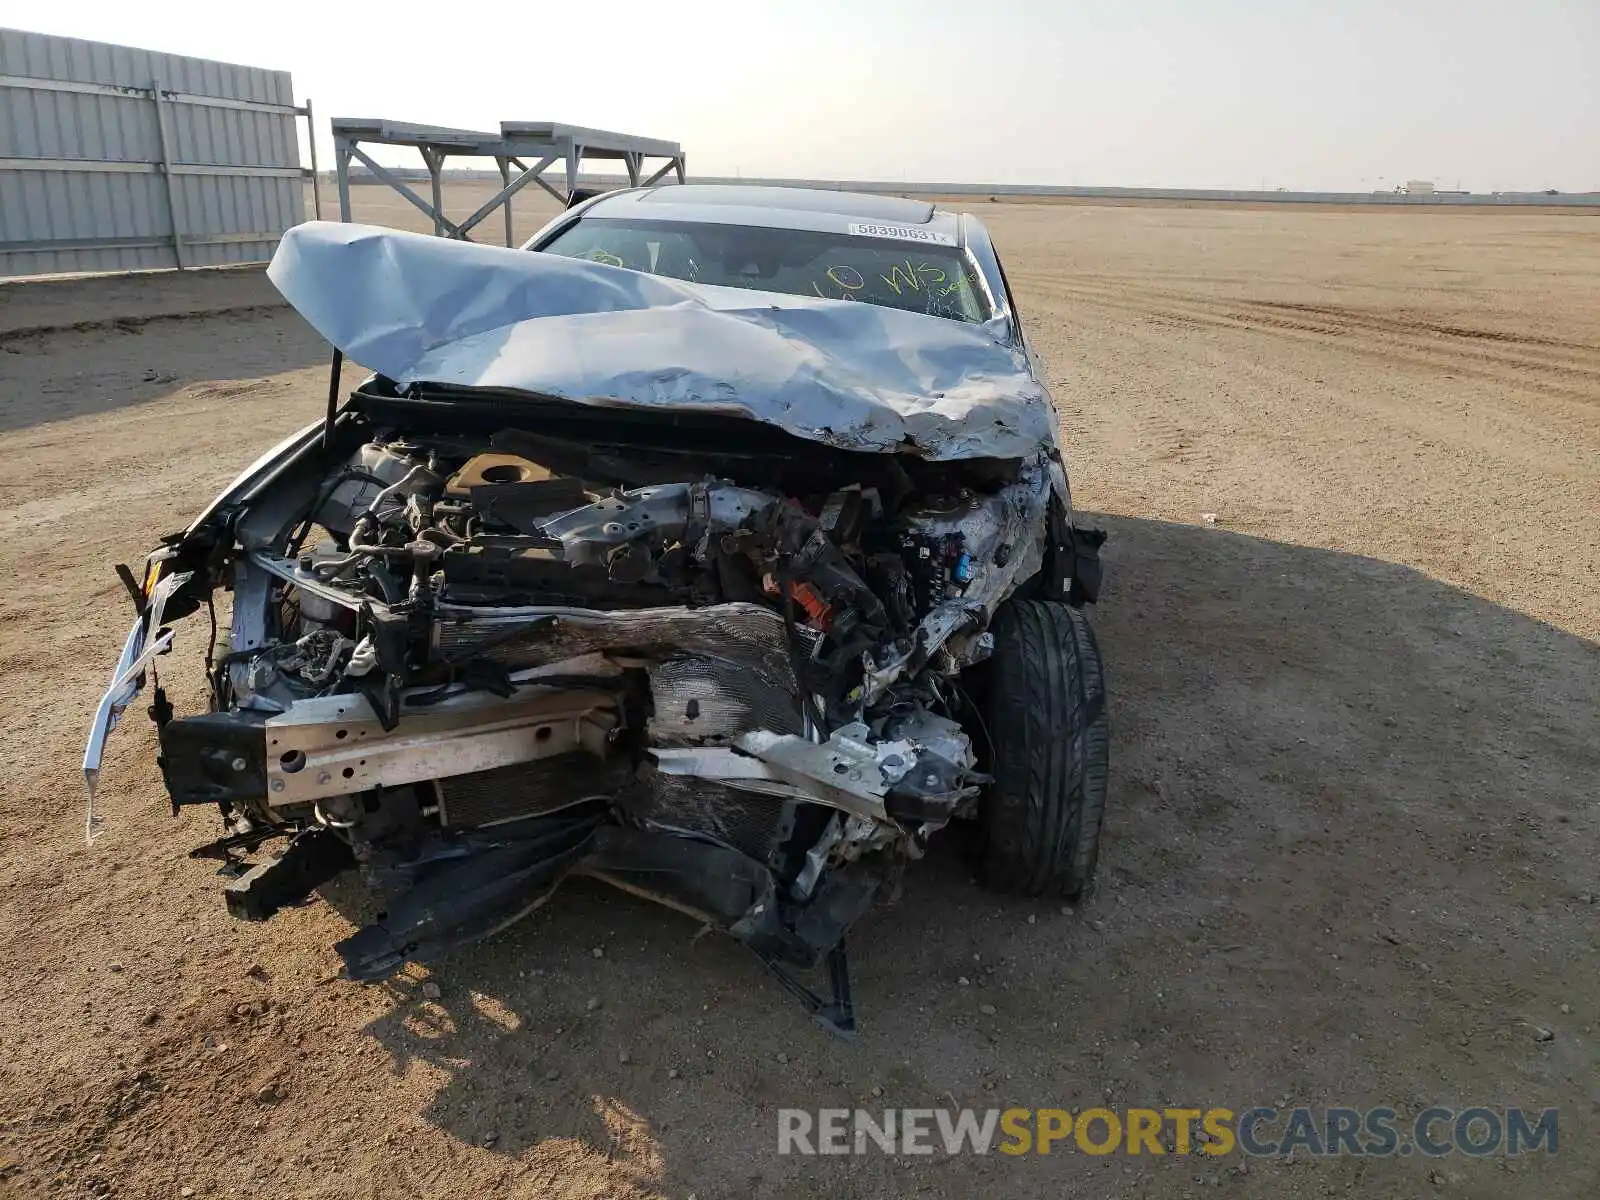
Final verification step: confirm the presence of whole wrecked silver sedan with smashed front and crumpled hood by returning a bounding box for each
[83,186,1107,1032]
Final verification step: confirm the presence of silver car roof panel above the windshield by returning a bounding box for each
[582,184,962,243]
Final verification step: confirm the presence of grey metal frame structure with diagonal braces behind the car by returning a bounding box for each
[333,117,685,246]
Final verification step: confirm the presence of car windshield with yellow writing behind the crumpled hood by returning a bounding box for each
[541,218,990,322]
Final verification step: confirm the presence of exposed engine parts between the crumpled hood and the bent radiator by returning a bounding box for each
[248,432,1046,728]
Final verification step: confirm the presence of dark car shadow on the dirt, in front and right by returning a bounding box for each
[344,518,1600,1200]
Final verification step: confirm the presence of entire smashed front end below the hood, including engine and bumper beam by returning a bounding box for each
[96,398,1083,1024]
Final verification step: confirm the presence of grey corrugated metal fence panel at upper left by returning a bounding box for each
[0,29,315,277]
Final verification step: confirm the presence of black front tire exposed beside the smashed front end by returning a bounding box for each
[979,598,1110,899]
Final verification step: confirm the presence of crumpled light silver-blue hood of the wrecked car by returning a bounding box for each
[267,221,1054,459]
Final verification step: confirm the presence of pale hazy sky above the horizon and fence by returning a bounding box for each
[0,0,1600,190]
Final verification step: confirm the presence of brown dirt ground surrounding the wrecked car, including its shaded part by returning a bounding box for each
[0,189,1600,1200]
